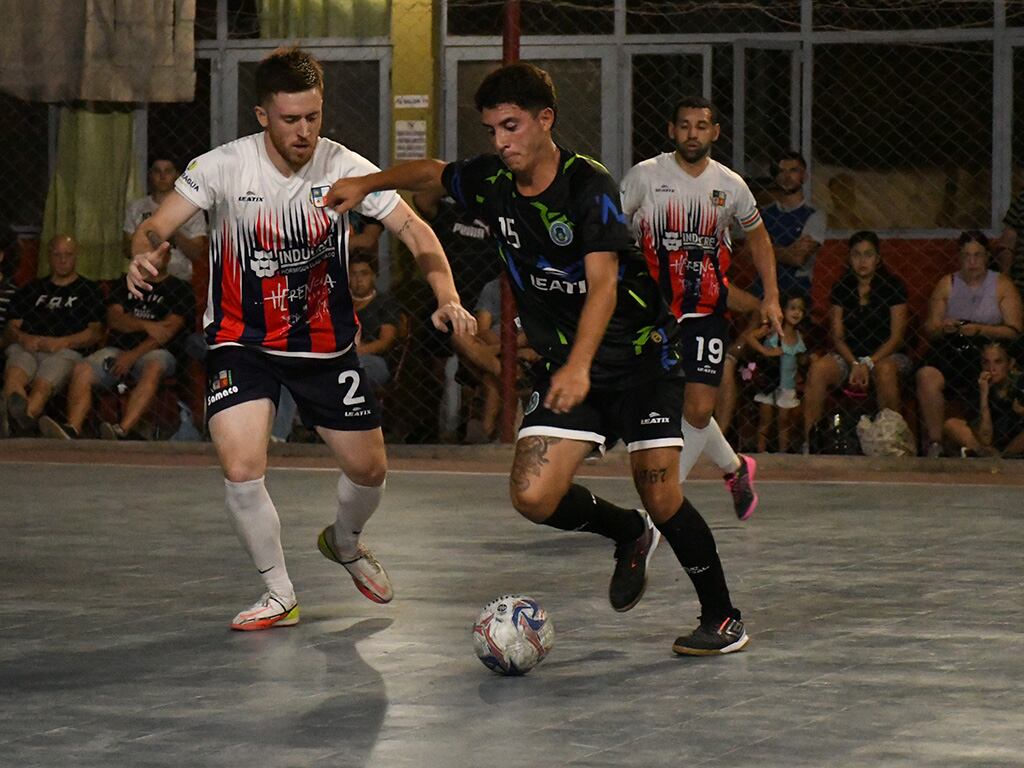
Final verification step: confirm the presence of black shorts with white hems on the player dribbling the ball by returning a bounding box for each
[517,374,685,453]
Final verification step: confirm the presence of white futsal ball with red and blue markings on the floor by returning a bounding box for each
[473,595,555,675]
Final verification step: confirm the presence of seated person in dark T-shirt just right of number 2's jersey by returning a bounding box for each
[348,254,400,388]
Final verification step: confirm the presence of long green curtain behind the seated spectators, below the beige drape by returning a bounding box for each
[39,106,143,280]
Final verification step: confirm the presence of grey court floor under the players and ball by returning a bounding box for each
[0,456,1024,768]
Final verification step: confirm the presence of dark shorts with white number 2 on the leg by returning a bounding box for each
[206,346,381,432]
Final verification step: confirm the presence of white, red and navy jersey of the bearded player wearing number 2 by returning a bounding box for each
[175,133,398,357]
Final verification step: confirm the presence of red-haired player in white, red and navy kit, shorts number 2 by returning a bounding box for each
[128,48,476,630]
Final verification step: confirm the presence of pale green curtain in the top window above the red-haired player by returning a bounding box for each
[259,0,390,40]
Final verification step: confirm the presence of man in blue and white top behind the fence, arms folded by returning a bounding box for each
[752,152,825,298]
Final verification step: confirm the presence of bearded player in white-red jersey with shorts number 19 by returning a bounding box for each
[621,97,782,520]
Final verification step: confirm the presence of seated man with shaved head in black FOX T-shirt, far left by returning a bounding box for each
[2,234,103,435]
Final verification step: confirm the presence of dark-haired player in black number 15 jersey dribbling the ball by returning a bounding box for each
[327,63,749,655]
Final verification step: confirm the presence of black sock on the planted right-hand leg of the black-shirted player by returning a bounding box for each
[657,499,739,622]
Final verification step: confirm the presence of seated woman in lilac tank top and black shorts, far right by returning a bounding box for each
[918,231,1024,457]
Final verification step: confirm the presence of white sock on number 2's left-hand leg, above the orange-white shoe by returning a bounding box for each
[224,477,295,598]
